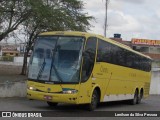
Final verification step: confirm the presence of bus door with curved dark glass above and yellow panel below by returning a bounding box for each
[79,37,97,103]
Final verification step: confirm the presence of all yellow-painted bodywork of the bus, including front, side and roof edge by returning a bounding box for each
[27,31,151,104]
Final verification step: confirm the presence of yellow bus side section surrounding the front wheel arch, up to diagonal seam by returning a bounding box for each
[78,62,111,104]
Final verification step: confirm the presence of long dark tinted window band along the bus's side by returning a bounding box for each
[97,39,151,71]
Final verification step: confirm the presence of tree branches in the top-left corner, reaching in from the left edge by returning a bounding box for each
[0,0,31,41]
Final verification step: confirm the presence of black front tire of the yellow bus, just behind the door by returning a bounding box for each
[87,90,99,111]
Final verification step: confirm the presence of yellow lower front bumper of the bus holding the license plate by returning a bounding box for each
[27,89,78,104]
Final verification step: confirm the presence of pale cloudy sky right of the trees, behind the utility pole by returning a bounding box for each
[82,0,160,41]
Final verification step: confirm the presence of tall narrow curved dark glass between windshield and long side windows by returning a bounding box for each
[81,37,97,82]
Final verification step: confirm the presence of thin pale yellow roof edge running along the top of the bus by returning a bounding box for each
[40,31,151,59]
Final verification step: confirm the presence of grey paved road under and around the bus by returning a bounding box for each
[0,95,160,120]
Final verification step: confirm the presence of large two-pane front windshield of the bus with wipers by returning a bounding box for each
[28,36,84,83]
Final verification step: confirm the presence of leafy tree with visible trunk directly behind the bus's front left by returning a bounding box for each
[21,0,93,74]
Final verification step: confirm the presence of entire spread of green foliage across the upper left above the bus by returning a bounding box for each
[0,0,93,41]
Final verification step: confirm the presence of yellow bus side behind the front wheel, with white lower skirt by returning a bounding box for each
[93,63,150,101]
